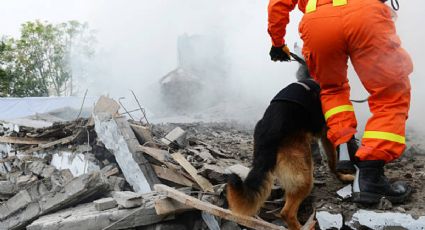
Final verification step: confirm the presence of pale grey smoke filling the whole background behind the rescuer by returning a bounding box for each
[0,0,425,132]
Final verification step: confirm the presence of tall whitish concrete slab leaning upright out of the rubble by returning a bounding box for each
[94,113,160,193]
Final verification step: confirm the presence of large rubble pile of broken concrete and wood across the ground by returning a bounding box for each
[0,97,425,230]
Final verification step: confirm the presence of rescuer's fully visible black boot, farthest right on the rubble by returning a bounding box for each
[353,161,412,204]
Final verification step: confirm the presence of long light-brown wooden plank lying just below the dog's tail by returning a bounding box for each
[154,184,286,230]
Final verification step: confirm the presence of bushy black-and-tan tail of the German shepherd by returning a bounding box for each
[227,167,273,216]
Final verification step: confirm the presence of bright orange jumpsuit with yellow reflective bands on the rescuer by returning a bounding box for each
[268,0,413,162]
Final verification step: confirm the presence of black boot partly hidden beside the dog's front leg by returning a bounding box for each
[336,136,359,174]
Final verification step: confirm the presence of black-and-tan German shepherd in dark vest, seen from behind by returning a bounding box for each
[226,54,354,230]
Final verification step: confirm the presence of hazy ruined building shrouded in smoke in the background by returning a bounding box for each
[159,34,229,113]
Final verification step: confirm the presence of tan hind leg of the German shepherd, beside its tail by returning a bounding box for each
[275,137,313,230]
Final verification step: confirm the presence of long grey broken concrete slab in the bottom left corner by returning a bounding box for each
[0,173,108,229]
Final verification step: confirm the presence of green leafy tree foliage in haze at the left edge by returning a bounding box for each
[0,21,94,97]
